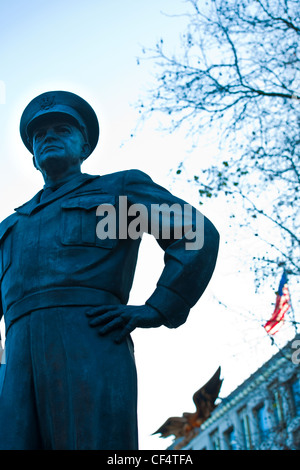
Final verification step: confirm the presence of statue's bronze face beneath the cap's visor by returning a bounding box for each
[32,118,89,175]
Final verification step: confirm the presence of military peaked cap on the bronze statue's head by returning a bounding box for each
[20,91,100,155]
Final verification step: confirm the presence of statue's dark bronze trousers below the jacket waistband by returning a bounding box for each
[0,306,138,450]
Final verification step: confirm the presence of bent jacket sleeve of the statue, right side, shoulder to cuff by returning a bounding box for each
[124,170,219,328]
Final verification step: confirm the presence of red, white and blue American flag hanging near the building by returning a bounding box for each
[264,271,291,335]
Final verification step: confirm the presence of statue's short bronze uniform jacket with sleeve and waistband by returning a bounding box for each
[0,170,218,331]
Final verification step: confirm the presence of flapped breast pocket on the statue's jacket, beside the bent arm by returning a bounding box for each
[60,194,117,249]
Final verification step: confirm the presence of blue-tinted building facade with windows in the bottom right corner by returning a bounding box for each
[180,335,300,450]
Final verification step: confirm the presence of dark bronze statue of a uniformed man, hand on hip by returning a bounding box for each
[0,91,219,450]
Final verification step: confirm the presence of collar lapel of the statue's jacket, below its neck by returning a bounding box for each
[15,173,99,215]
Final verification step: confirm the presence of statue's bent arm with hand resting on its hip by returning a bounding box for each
[87,170,219,342]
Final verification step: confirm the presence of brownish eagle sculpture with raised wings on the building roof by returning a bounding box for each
[153,367,223,449]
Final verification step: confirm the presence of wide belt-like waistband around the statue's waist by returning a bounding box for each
[4,287,121,334]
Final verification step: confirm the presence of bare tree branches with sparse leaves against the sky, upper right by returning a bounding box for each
[139,0,300,288]
